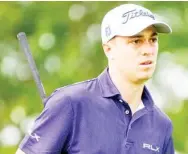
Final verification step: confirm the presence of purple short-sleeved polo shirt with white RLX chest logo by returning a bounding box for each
[20,68,174,154]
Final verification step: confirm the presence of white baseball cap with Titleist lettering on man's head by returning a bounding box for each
[101,4,172,44]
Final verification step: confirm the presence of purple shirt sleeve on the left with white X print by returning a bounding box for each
[19,91,73,154]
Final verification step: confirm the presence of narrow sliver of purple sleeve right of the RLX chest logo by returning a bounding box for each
[163,124,175,154]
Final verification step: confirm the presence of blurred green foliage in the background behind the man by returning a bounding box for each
[0,1,188,154]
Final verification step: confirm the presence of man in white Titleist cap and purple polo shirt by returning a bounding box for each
[17,4,174,154]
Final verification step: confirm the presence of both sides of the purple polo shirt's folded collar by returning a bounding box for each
[98,67,154,110]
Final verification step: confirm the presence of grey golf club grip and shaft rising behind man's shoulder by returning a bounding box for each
[17,32,46,103]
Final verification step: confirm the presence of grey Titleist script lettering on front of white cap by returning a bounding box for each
[122,9,155,24]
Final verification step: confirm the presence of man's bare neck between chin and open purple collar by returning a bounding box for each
[109,68,144,113]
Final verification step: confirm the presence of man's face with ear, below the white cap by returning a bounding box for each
[103,26,158,83]
